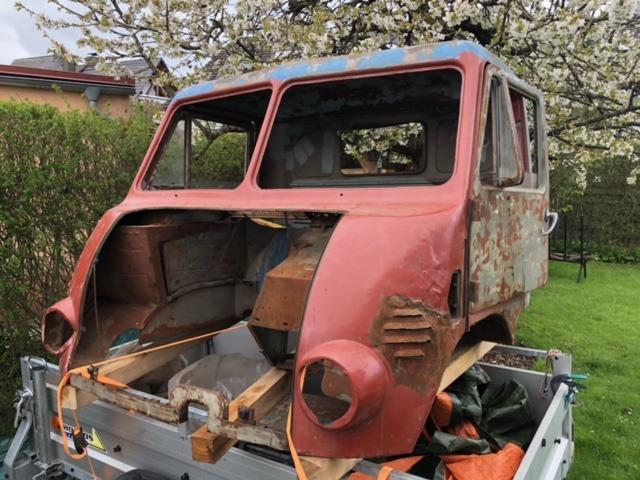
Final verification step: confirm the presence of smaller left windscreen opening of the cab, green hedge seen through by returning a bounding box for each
[146,91,269,190]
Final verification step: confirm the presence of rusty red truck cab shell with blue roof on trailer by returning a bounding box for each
[42,42,549,457]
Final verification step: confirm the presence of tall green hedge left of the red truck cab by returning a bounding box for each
[0,102,154,433]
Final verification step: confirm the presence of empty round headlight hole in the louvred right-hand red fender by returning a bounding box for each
[302,360,352,425]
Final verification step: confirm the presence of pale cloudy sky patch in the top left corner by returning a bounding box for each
[0,0,78,65]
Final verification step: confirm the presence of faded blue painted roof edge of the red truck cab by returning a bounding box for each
[173,41,515,102]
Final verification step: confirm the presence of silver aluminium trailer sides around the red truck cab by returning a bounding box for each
[4,345,574,480]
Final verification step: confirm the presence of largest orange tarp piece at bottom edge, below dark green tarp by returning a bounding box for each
[441,443,524,480]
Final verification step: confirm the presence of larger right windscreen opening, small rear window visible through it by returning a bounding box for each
[258,69,462,189]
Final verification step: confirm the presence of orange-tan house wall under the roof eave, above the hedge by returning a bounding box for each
[0,85,131,118]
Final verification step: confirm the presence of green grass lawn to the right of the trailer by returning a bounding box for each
[518,262,640,480]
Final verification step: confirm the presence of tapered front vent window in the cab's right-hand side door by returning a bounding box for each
[480,77,528,187]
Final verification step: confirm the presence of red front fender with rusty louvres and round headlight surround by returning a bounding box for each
[292,209,466,457]
